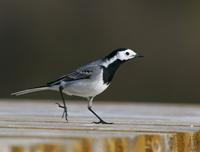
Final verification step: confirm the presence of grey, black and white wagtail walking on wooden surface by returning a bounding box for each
[11,48,144,124]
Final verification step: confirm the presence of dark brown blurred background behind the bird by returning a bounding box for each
[0,0,200,103]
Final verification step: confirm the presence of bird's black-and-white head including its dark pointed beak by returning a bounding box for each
[106,48,144,62]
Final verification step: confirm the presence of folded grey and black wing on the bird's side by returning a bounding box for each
[47,64,98,86]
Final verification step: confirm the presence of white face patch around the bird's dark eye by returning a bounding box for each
[117,49,136,61]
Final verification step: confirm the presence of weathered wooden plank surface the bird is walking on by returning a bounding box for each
[0,100,200,152]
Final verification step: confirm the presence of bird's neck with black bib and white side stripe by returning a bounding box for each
[102,56,124,84]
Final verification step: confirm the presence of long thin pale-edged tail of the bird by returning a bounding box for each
[11,86,49,96]
